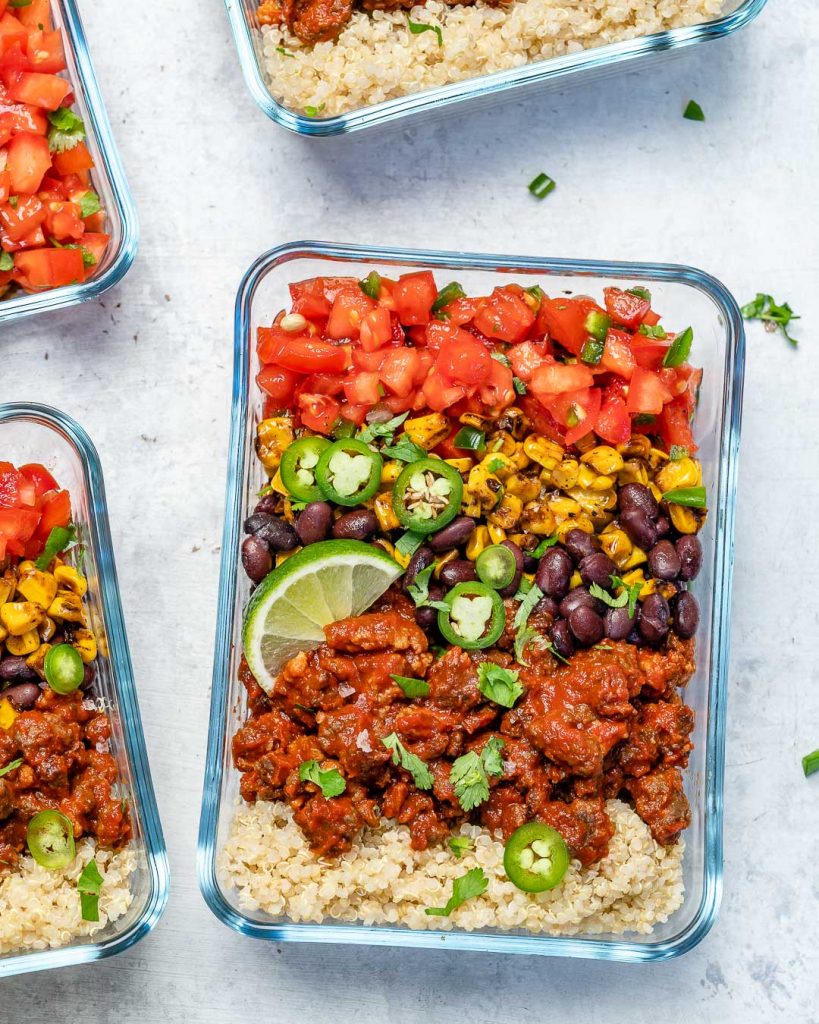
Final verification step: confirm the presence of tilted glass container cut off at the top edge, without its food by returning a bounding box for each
[224,0,767,136]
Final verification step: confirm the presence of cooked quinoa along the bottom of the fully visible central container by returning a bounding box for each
[219,800,684,935]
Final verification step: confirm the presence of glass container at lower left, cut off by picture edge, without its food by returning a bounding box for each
[0,402,169,978]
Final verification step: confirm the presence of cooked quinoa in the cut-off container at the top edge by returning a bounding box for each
[261,0,735,117]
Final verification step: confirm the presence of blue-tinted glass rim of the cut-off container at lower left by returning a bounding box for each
[0,402,170,978]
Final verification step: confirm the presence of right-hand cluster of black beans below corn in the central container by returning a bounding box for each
[534,483,702,657]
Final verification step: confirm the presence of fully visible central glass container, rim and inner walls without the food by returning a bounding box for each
[199,242,744,961]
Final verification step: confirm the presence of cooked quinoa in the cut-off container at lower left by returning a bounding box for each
[0,839,136,955]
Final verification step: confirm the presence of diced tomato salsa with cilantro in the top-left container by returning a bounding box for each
[0,0,111,297]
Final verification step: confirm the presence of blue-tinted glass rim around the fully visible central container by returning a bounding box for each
[197,241,745,963]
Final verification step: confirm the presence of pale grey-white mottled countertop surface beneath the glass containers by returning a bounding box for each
[0,0,819,1024]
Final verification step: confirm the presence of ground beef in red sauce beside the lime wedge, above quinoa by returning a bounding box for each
[232,590,694,864]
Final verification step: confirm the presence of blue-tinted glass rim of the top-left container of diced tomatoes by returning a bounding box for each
[0,0,139,324]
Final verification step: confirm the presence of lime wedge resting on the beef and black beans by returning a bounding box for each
[242,541,402,693]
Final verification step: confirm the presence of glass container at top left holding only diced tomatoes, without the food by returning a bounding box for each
[0,0,139,324]
